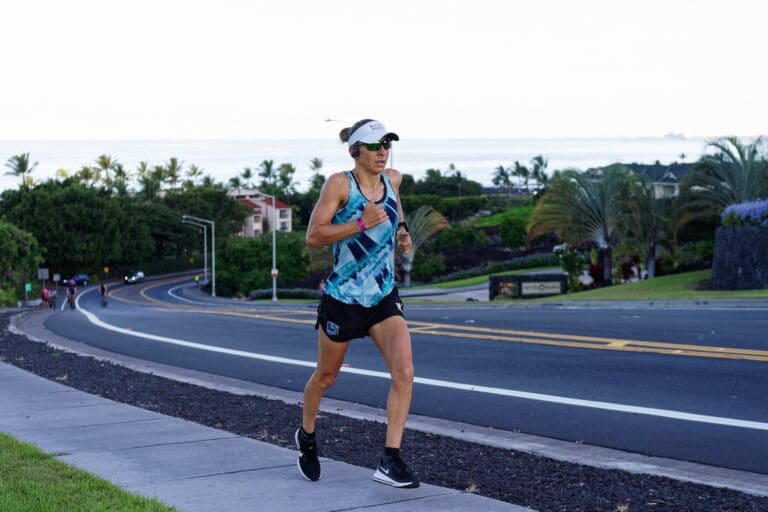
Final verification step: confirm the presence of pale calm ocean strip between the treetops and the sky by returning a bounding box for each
[0,137,708,191]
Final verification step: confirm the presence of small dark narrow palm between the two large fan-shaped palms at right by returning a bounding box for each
[618,175,672,279]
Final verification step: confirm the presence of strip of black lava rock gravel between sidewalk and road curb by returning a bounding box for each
[0,312,768,512]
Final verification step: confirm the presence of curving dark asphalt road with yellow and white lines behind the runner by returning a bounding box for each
[46,281,768,474]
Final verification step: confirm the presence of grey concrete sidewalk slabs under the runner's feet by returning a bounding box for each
[0,363,530,512]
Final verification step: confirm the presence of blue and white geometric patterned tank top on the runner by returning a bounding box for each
[325,171,398,307]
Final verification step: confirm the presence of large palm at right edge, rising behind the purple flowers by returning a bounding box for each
[675,137,768,229]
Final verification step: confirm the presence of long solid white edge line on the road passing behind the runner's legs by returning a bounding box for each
[77,295,768,431]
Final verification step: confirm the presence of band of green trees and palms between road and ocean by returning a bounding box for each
[0,138,768,302]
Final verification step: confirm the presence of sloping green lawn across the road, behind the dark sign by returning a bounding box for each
[532,270,768,302]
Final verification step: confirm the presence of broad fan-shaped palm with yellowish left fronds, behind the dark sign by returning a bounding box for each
[528,165,629,284]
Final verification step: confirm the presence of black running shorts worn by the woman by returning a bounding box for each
[315,288,403,342]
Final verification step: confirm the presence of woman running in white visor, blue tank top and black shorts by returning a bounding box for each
[295,119,419,487]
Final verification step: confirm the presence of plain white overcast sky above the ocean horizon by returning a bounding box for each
[0,0,768,139]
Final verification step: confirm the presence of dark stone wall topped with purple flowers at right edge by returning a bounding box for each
[712,226,768,290]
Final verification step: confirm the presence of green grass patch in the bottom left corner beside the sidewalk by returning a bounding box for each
[0,433,176,512]
